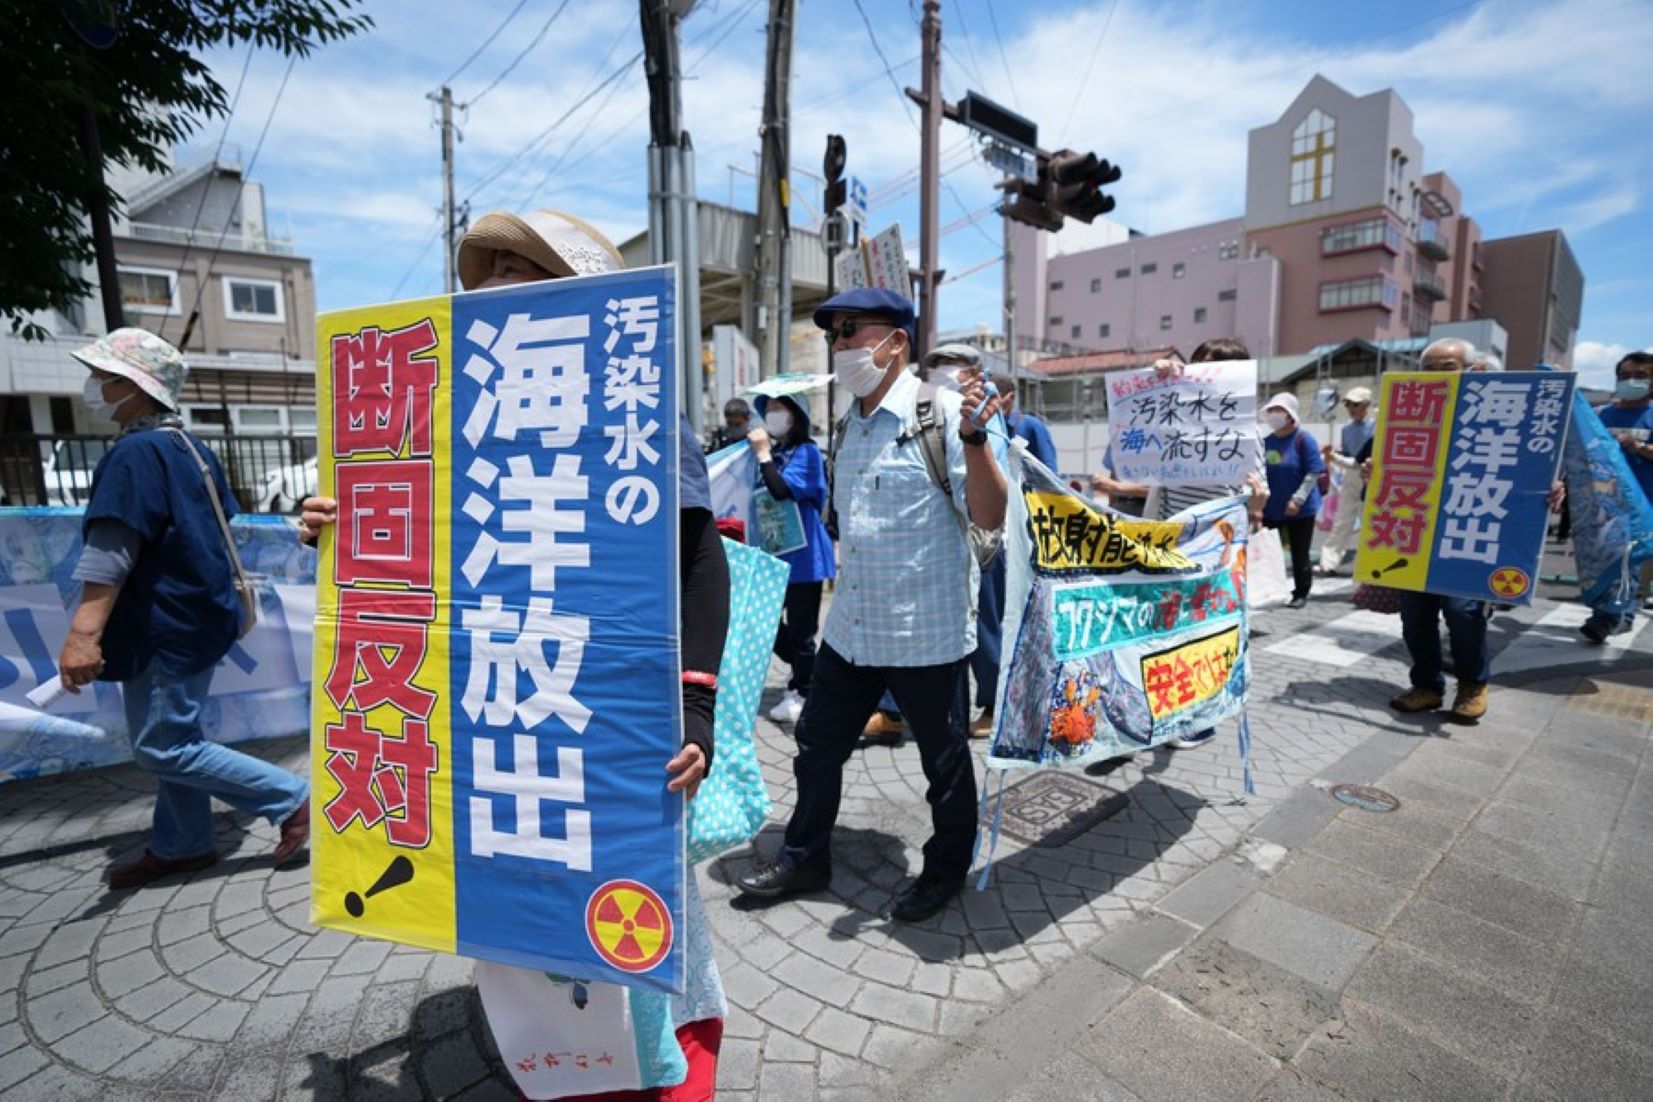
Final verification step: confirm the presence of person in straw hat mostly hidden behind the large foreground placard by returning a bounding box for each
[301,210,729,1102]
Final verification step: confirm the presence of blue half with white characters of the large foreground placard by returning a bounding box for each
[450,268,684,991]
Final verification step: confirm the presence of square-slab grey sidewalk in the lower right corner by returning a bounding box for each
[899,671,1653,1100]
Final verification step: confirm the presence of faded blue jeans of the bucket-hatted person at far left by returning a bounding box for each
[121,661,309,861]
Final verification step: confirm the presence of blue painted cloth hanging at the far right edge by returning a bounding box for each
[1565,393,1653,616]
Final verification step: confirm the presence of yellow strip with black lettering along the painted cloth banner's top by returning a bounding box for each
[1023,491,1197,573]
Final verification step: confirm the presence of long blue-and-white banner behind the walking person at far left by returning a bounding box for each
[0,507,316,783]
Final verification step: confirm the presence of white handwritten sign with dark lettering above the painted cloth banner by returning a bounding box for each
[1108,360,1263,486]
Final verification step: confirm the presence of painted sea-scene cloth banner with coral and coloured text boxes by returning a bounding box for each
[987,443,1250,768]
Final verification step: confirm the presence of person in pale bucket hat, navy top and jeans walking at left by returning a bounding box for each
[58,329,309,889]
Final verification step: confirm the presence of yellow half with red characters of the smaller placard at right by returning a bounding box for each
[1354,372,1460,593]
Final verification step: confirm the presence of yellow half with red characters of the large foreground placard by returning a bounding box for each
[311,296,456,953]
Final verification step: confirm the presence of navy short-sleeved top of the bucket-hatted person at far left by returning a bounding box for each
[83,430,241,681]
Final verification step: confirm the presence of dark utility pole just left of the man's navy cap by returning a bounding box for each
[757,0,797,377]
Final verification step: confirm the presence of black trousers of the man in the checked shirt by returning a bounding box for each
[782,644,975,879]
